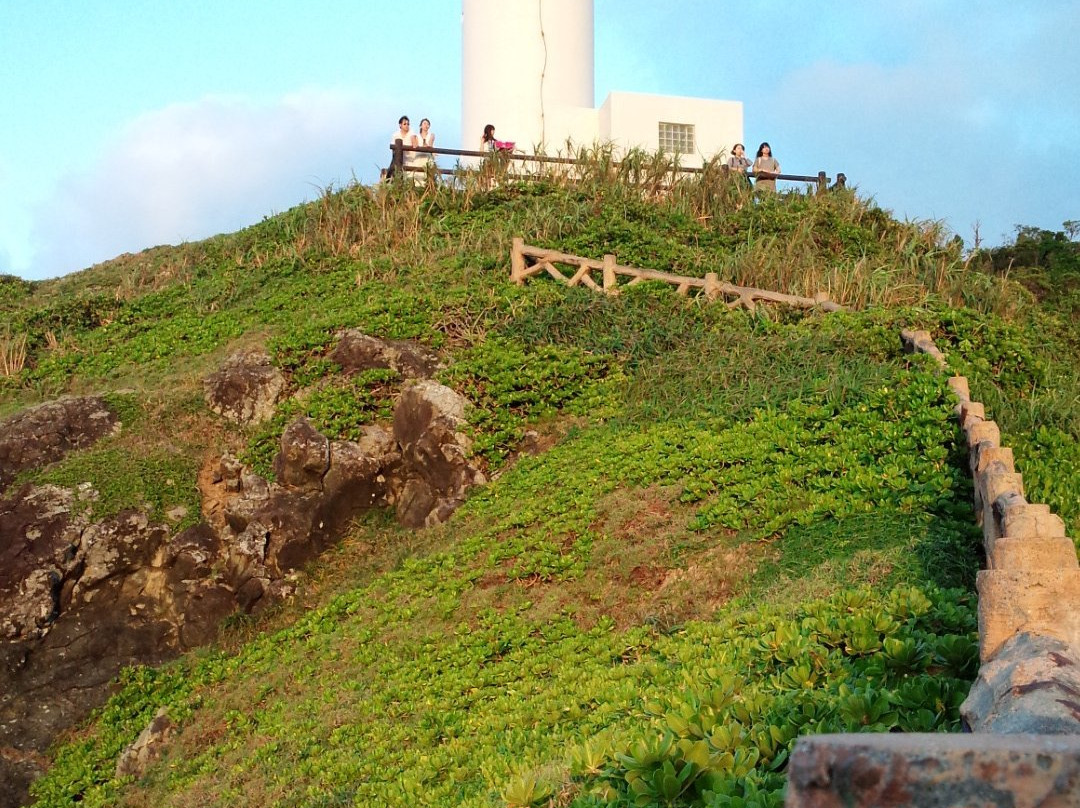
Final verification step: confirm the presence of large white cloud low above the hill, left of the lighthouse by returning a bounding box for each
[26,91,396,278]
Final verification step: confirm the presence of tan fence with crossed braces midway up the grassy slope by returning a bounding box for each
[510,238,843,311]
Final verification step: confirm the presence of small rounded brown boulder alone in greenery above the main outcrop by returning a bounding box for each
[204,351,285,426]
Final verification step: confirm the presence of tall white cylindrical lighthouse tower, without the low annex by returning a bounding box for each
[461,0,596,152]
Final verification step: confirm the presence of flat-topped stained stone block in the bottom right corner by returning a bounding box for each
[784,732,1080,808]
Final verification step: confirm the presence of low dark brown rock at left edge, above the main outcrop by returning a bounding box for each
[0,395,119,494]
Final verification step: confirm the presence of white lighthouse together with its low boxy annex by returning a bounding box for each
[461,0,743,166]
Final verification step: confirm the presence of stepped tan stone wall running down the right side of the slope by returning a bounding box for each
[786,331,1080,808]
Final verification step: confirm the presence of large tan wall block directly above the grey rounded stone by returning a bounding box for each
[975,569,1080,662]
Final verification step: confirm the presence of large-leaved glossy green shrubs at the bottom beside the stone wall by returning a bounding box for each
[565,588,978,808]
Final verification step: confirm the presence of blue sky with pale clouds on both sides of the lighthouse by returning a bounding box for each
[0,0,1080,279]
